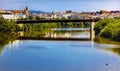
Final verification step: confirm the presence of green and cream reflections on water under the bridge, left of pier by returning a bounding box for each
[21,28,90,38]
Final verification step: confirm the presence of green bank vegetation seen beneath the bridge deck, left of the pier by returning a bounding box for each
[22,22,90,37]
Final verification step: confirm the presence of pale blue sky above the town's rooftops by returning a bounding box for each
[0,0,120,12]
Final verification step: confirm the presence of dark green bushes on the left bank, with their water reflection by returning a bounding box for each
[0,18,20,54]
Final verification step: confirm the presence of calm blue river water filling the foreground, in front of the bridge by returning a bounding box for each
[0,30,120,71]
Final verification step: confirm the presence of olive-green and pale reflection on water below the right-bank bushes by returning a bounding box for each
[94,36,120,56]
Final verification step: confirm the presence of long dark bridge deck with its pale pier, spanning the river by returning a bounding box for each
[16,19,99,40]
